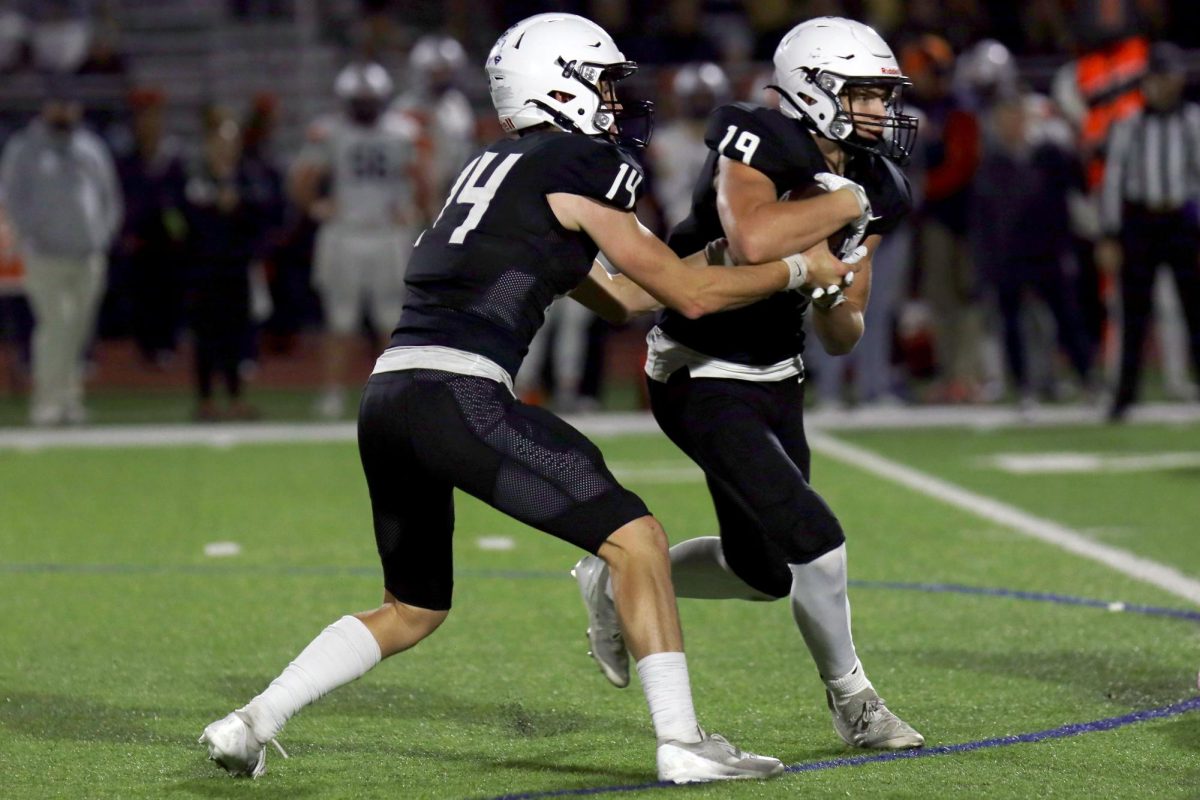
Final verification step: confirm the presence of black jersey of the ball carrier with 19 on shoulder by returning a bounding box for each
[659,103,912,366]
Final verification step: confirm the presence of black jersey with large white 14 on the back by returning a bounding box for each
[391,131,642,375]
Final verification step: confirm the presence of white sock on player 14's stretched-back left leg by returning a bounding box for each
[238,616,380,741]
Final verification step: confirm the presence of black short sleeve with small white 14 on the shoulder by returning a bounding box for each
[540,133,644,211]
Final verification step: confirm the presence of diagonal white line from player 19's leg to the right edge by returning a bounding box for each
[809,433,1200,606]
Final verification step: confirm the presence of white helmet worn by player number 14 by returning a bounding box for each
[486,13,654,148]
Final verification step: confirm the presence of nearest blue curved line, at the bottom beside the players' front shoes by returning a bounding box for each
[490,697,1200,800]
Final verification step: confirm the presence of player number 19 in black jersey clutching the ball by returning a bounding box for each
[576,17,924,748]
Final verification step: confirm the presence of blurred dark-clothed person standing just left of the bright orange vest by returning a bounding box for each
[970,88,1092,408]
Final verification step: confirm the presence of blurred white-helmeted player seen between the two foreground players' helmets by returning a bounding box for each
[648,61,733,230]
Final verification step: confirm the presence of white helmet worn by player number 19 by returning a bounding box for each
[770,17,917,162]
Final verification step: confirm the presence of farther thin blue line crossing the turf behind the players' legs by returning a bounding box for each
[0,564,1200,622]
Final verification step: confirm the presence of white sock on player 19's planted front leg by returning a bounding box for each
[791,545,858,680]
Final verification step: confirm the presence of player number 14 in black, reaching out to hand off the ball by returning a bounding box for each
[200,14,848,782]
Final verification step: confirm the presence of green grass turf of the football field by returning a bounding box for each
[0,427,1200,800]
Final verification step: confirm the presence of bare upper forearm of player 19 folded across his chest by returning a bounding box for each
[718,191,860,264]
